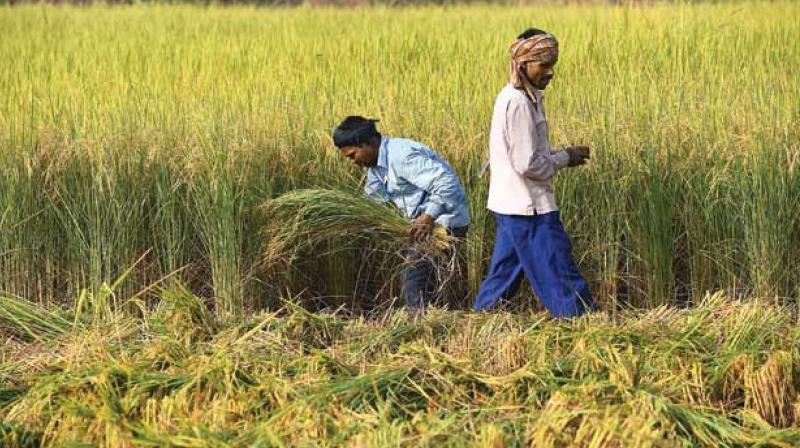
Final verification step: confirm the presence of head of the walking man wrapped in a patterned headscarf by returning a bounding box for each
[510,28,558,90]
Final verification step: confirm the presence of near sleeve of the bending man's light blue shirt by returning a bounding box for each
[401,153,464,219]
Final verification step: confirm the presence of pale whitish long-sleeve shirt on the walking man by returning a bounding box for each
[487,84,569,215]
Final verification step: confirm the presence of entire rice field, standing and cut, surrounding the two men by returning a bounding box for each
[0,1,800,447]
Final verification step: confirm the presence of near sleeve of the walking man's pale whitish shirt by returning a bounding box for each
[506,101,569,180]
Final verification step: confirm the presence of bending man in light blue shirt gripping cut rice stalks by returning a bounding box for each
[333,116,469,309]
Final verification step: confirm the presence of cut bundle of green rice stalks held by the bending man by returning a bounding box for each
[262,189,454,267]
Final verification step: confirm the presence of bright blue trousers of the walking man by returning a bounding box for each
[473,211,594,317]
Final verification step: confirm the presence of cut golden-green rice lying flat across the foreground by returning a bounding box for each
[0,290,800,447]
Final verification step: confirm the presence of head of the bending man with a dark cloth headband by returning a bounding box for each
[333,115,381,167]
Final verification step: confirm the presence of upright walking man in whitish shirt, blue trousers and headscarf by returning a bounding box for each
[473,28,594,317]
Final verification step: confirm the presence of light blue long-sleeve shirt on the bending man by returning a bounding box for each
[364,137,469,229]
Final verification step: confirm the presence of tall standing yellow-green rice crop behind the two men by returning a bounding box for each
[0,2,800,315]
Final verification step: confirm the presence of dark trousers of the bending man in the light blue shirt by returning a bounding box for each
[400,227,468,308]
